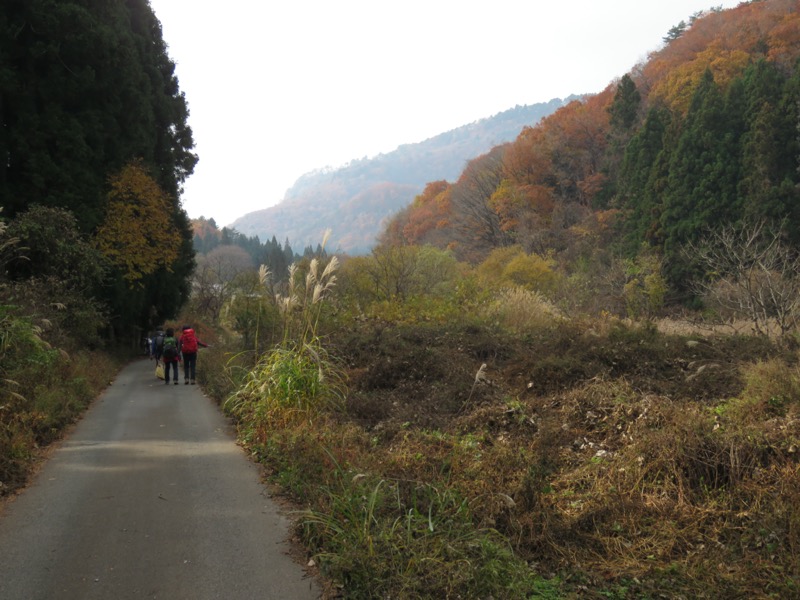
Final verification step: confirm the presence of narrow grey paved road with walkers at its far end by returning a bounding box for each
[0,360,319,600]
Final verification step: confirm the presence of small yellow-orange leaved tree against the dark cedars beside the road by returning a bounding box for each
[95,161,181,286]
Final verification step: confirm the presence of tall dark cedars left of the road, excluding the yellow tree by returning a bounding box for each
[0,0,197,333]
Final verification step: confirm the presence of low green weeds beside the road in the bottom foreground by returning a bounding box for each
[301,472,556,598]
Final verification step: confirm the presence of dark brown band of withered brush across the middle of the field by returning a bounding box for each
[336,323,775,435]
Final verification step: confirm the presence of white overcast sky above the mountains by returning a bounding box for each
[150,0,739,226]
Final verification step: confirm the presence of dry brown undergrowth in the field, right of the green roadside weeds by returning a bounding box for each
[266,319,800,598]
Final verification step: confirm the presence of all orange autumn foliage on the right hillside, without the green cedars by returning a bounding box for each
[382,0,800,258]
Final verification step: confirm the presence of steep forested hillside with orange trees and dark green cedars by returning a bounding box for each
[380,0,800,290]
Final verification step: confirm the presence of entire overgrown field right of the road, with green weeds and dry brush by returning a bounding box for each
[198,244,800,598]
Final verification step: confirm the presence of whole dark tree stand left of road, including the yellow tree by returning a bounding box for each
[0,0,197,336]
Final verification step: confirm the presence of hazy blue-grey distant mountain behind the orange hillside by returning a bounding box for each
[231,96,578,254]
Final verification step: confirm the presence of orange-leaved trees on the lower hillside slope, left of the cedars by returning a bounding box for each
[390,89,613,247]
